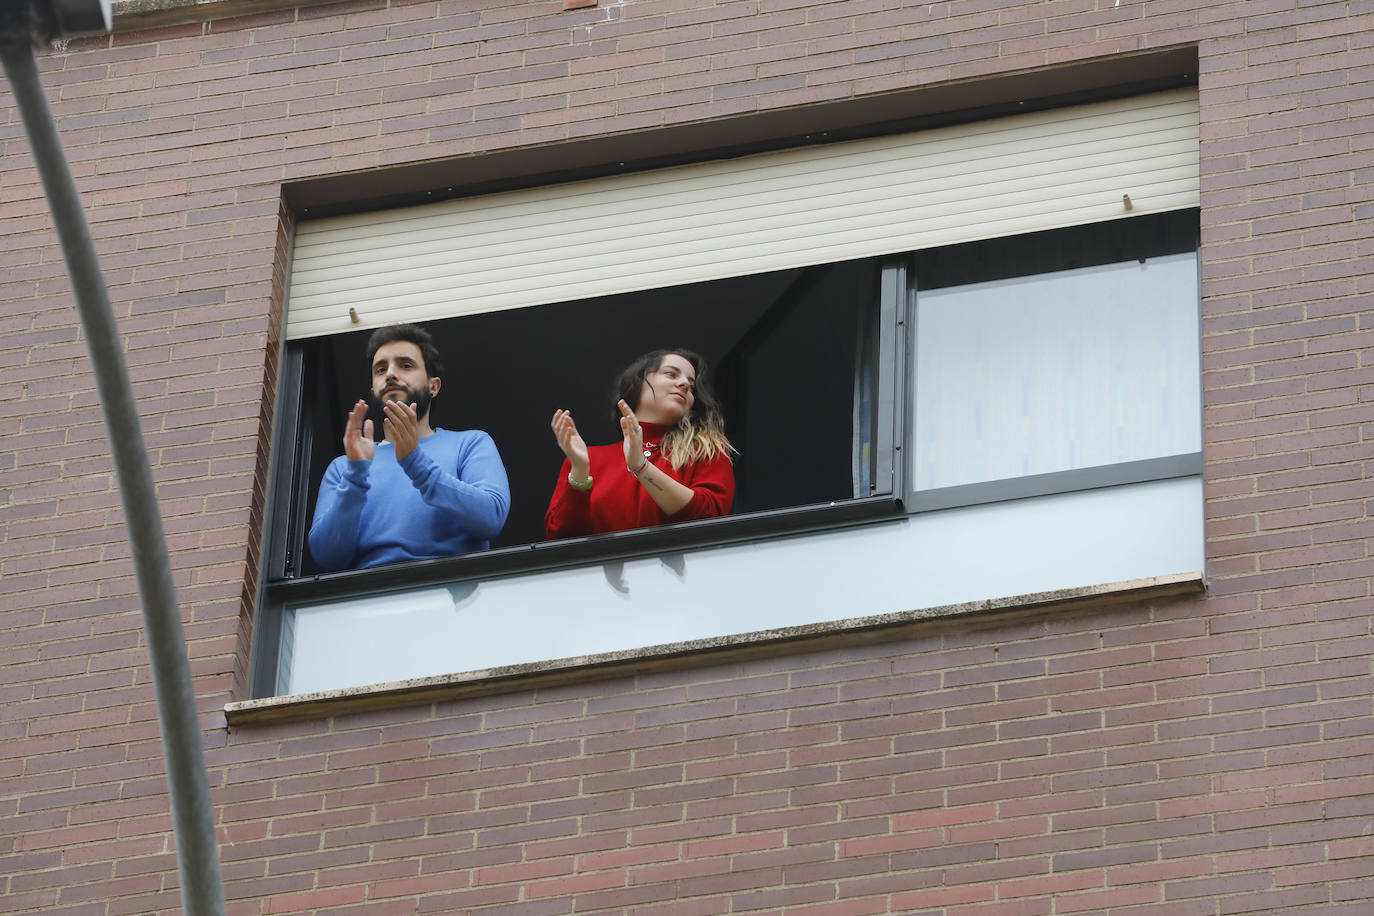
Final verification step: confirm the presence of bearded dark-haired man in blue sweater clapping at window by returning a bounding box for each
[311,324,511,573]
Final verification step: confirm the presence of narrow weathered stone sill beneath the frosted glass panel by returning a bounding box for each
[224,571,1205,726]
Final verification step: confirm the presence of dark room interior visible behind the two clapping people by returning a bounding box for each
[293,261,877,574]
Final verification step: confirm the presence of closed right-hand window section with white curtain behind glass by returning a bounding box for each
[907,211,1202,508]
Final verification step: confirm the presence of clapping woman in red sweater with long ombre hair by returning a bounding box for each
[544,350,735,540]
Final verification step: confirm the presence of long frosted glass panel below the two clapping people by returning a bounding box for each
[279,478,1202,694]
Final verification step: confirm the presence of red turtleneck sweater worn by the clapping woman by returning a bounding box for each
[544,422,735,541]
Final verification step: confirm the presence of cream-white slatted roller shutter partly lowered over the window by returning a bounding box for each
[287,89,1198,338]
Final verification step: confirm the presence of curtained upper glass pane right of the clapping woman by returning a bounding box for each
[912,251,1201,489]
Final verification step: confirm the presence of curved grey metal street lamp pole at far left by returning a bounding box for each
[0,0,224,916]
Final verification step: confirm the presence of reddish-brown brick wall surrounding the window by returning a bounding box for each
[0,0,1374,916]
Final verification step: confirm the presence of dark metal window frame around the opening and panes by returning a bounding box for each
[253,218,1202,698]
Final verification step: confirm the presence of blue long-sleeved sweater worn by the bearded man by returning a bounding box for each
[311,430,511,573]
